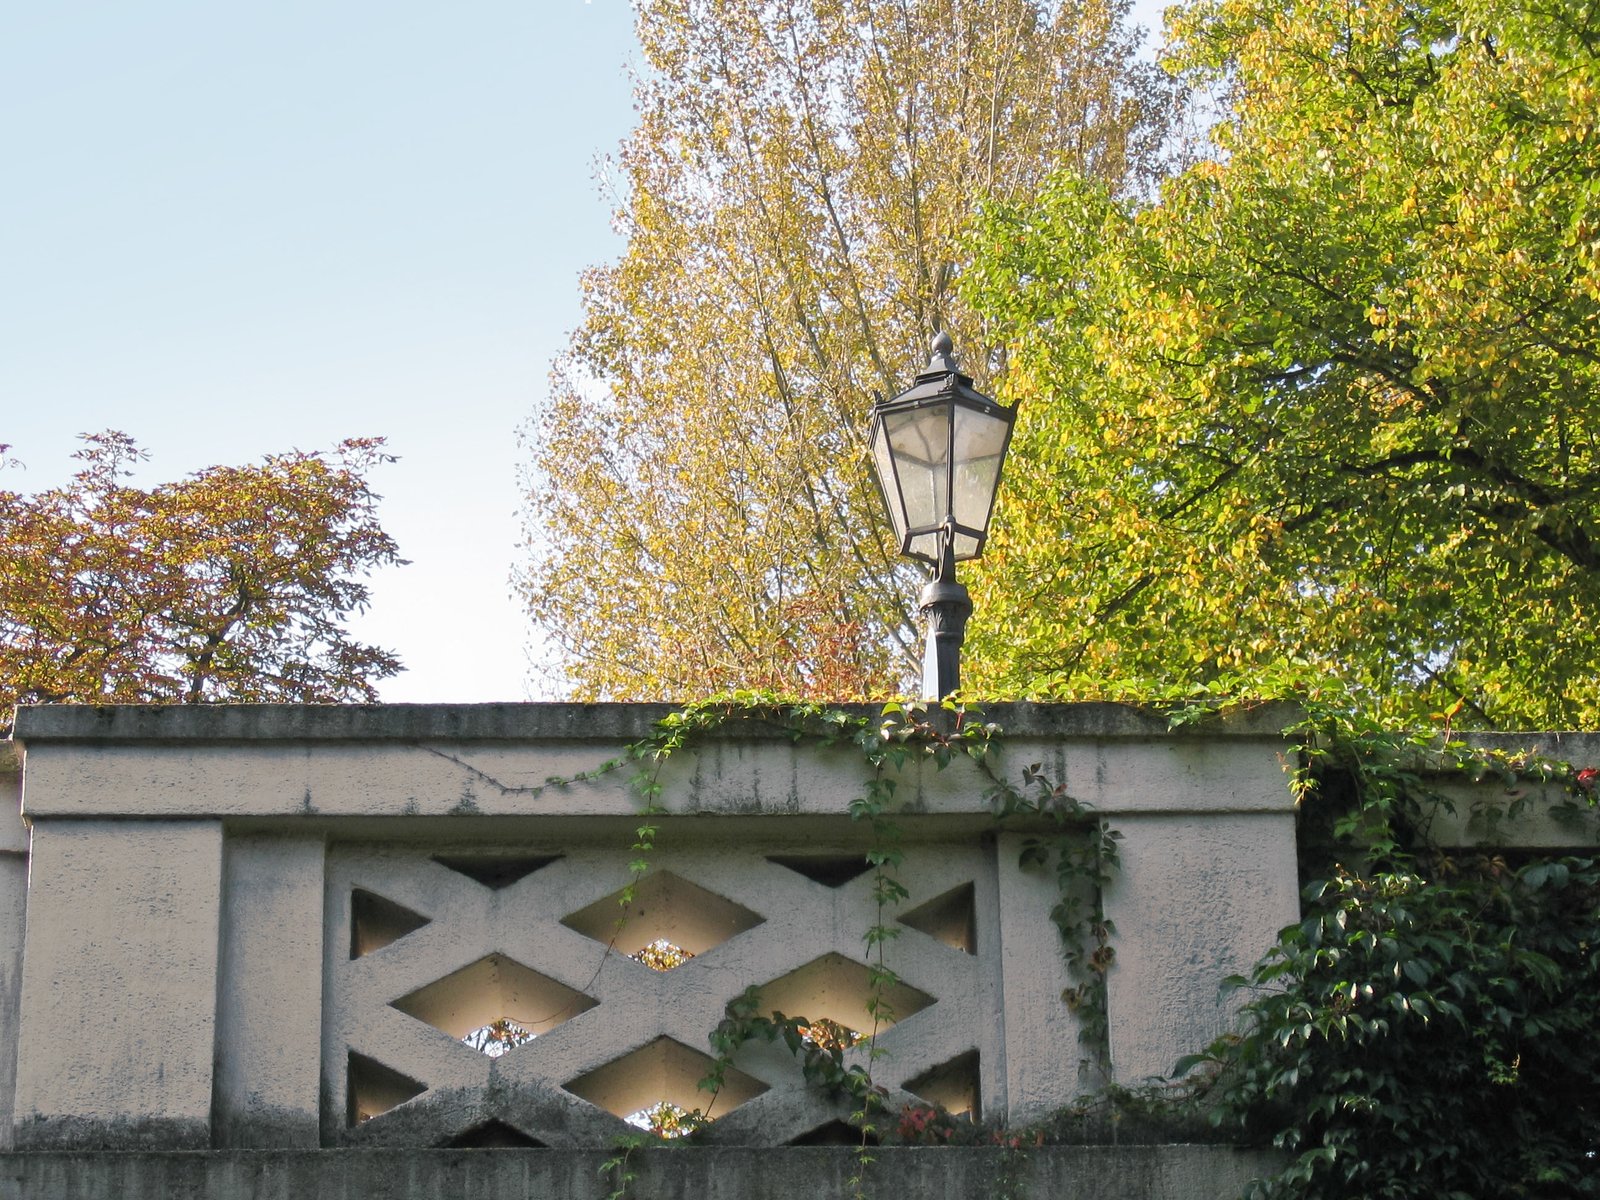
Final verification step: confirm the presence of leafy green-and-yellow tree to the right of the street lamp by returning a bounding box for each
[968,0,1600,728]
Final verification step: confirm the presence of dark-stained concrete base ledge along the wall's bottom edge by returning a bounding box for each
[0,1146,1275,1200]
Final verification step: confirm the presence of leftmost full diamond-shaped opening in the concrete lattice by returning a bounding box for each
[390,954,598,1058]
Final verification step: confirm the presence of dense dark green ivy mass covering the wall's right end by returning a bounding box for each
[1178,714,1600,1200]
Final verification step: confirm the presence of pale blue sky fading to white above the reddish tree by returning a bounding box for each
[0,0,1155,701]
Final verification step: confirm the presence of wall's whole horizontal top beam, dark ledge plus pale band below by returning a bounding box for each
[18,704,1286,821]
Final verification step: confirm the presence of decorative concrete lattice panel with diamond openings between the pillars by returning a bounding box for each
[322,830,1003,1147]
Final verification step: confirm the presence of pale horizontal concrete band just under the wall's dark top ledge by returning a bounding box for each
[12,723,1288,821]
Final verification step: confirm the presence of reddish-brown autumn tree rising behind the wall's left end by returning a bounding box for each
[0,432,403,729]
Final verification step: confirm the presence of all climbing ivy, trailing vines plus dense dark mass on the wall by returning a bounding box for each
[605,694,1600,1200]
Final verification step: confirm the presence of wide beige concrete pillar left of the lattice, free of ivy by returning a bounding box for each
[14,821,222,1149]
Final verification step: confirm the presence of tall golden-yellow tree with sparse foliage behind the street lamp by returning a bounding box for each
[520,0,1173,699]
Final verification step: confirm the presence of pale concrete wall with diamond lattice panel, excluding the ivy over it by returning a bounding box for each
[0,706,1298,1158]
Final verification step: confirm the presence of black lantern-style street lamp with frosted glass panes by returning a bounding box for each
[872,333,1016,701]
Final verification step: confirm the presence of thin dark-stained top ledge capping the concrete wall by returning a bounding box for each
[13,702,1299,746]
